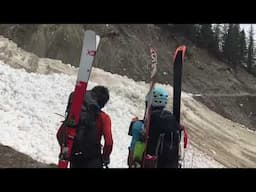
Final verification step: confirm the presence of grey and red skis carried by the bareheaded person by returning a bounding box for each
[58,30,100,168]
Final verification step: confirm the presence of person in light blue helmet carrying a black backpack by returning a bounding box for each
[128,86,187,168]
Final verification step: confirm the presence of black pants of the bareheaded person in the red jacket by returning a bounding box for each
[70,155,103,168]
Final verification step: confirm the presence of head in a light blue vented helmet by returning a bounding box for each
[146,86,169,107]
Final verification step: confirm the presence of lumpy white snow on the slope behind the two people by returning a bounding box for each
[0,62,222,168]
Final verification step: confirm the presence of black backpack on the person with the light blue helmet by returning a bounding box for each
[147,110,181,167]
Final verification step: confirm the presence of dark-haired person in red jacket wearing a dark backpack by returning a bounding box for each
[57,86,113,168]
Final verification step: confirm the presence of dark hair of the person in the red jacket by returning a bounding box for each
[92,85,109,108]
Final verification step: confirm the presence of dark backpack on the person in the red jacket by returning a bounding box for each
[57,91,101,160]
